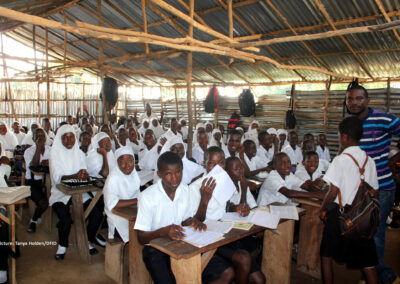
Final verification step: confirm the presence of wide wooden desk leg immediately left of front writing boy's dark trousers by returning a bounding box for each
[129,221,152,284]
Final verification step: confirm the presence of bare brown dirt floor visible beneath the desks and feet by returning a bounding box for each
[8,206,400,284]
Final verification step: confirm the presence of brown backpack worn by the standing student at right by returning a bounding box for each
[338,153,380,240]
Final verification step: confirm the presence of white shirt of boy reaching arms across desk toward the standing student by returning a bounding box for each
[257,170,303,206]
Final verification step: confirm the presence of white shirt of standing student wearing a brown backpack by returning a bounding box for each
[324,146,379,206]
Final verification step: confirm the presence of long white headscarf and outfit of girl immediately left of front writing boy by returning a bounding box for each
[103,146,140,242]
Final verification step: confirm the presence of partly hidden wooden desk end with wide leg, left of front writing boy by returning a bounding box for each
[112,206,152,284]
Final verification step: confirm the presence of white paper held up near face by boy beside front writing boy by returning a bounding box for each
[205,165,236,206]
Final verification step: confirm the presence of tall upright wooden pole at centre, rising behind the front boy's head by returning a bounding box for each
[186,0,194,158]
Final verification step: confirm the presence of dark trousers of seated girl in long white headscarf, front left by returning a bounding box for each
[53,198,104,247]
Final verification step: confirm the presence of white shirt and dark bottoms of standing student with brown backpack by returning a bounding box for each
[320,146,379,268]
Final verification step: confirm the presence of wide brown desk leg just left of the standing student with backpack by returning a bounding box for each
[297,204,324,279]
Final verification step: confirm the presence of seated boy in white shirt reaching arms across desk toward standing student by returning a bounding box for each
[257,152,325,206]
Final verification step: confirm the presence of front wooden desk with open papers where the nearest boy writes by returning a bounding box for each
[150,220,294,284]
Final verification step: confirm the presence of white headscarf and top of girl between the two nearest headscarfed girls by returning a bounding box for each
[86,132,117,178]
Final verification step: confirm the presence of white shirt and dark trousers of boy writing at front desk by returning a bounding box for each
[134,180,230,283]
